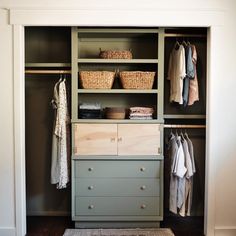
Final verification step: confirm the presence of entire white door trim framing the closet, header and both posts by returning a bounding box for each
[10,9,224,236]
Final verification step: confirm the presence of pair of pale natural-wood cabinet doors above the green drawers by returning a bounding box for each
[74,124,161,156]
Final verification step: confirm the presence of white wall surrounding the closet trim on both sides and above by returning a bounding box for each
[0,0,236,236]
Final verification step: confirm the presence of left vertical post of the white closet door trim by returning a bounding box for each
[13,25,26,236]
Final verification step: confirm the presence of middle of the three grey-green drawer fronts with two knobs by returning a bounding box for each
[75,178,160,197]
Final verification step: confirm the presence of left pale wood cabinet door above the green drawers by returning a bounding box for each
[74,124,117,155]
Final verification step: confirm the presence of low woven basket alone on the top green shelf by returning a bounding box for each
[99,48,132,59]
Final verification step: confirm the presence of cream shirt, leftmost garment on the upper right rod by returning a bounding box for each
[167,45,186,104]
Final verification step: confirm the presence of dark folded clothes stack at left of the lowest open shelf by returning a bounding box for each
[79,103,102,119]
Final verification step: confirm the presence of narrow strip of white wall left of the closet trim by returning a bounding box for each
[0,10,15,236]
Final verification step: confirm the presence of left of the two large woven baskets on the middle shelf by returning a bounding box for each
[79,71,115,89]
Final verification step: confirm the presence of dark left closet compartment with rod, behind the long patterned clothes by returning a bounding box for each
[25,27,72,235]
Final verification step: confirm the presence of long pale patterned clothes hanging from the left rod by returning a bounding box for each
[51,79,69,189]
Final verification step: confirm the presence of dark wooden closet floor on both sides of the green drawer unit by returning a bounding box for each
[27,216,203,236]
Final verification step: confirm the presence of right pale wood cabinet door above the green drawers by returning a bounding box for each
[118,124,161,155]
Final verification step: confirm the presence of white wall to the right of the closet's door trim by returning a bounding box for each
[215,1,236,232]
